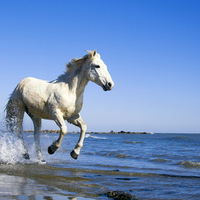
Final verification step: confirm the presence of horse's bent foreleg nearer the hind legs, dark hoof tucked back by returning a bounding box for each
[48,113,67,154]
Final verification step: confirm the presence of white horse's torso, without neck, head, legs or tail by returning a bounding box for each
[8,77,83,120]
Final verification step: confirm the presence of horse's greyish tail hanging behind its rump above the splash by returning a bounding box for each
[5,91,24,133]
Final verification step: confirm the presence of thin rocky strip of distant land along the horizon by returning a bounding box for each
[23,130,153,134]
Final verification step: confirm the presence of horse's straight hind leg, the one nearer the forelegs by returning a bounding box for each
[30,116,45,163]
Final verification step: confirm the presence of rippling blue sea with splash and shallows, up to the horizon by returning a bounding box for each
[0,132,200,200]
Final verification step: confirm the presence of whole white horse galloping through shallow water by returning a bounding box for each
[6,50,114,162]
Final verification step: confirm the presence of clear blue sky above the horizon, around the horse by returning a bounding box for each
[0,0,200,133]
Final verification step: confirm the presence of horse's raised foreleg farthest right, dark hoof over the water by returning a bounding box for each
[70,116,87,159]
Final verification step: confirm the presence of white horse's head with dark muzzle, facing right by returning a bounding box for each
[85,50,114,91]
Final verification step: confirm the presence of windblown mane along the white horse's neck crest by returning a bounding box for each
[66,50,96,72]
